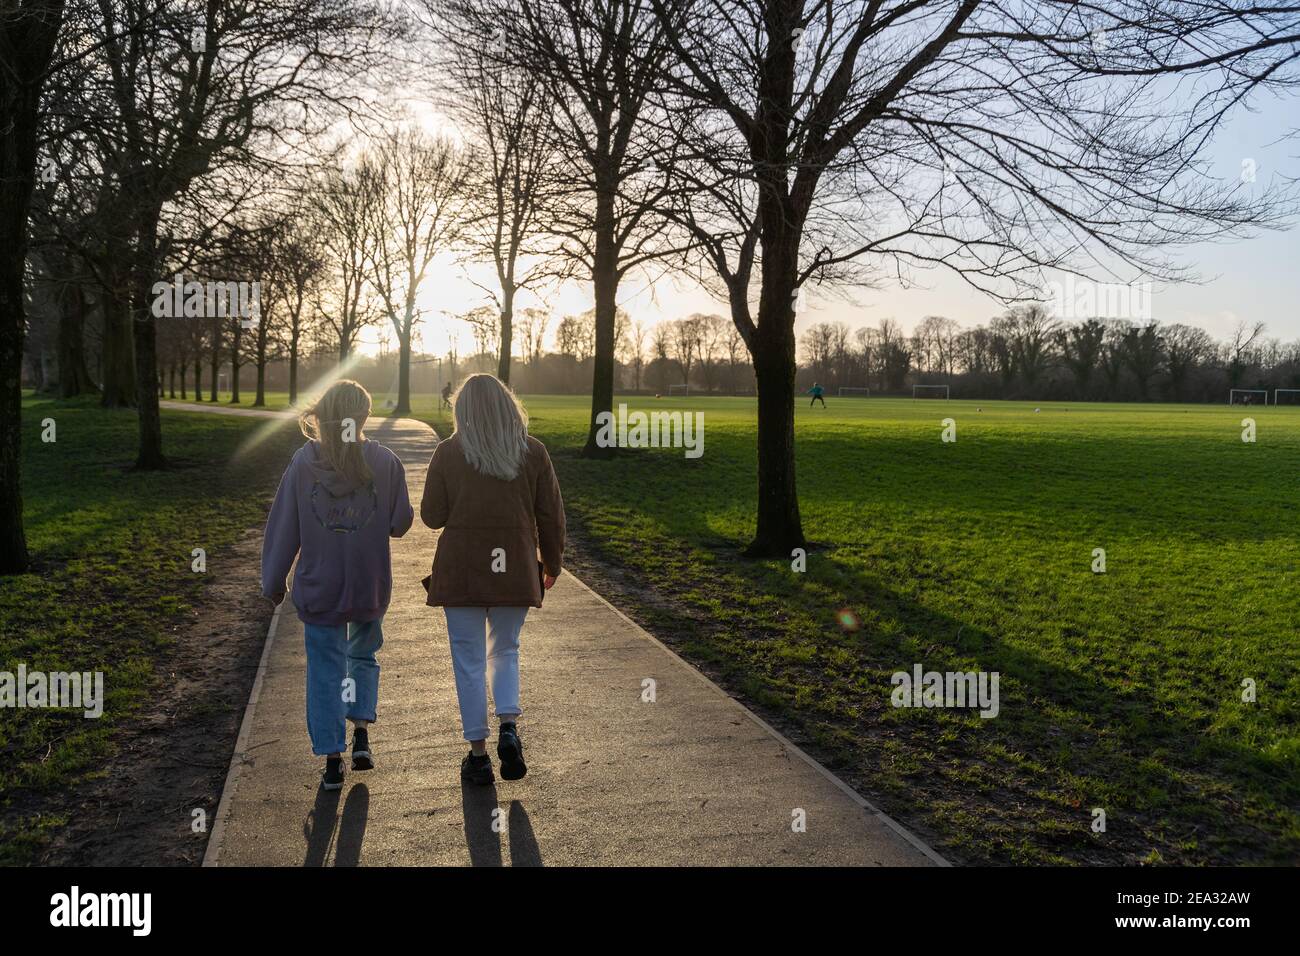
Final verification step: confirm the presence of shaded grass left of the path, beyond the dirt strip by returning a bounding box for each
[0,397,302,864]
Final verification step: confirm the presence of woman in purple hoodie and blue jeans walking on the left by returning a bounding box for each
[261,380,415,790]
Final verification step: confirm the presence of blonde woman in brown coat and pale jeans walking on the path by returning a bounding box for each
[420,375,564,784]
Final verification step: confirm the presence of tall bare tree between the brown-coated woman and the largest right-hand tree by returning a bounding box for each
[425,0,680,458]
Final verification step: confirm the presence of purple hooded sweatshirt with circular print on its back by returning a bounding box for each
[261,441,415,624]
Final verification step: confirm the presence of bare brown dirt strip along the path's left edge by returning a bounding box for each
[23,528,273,866]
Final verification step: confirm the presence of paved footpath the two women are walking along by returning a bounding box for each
[164,402,944,866]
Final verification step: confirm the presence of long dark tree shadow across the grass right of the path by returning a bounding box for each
[577,514,1300,864]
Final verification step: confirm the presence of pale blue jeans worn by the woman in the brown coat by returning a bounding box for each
[442,607,528,740]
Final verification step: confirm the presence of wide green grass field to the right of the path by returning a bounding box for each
[76,395,1300,864]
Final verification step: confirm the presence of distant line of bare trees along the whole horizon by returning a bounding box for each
[23,300,1300,402]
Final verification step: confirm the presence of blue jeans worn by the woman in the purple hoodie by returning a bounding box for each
[303,620,384,756]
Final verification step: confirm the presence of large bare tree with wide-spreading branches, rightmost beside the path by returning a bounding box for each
[650,0,1297,555]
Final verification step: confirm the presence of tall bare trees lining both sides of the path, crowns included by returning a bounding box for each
[0,0,1300,570]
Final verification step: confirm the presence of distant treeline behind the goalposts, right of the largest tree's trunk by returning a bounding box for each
[801,316,1300,402]
